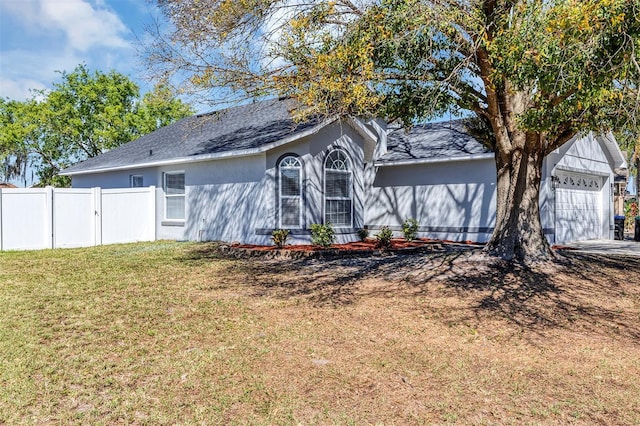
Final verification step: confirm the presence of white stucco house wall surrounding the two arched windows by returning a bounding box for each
[72,123,373,244]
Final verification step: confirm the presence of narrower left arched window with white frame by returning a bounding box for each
[278,155,302,228]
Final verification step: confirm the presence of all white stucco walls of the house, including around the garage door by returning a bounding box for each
[67,123,613,244]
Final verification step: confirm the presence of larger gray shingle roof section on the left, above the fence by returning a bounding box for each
[63,99,319,173]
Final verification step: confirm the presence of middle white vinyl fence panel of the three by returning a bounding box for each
[53,188,99,248]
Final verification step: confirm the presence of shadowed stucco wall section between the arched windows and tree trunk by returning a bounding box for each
[365,159,496,241]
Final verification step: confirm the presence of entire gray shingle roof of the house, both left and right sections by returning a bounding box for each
[63,99,490,174]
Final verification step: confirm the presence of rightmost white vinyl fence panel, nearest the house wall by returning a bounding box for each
[102,188,156,244]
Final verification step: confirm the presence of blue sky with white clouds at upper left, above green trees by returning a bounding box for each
[0,0,158,100]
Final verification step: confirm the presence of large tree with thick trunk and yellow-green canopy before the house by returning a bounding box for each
[147,0,640,260]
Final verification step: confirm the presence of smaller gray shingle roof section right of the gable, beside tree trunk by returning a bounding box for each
[377,120,491,164]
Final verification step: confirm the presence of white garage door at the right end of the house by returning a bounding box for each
[556,173,603,243]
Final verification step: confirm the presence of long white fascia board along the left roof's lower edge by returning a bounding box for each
[60,118,336,176]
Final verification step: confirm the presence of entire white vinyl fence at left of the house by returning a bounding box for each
[0,186,156,250]
